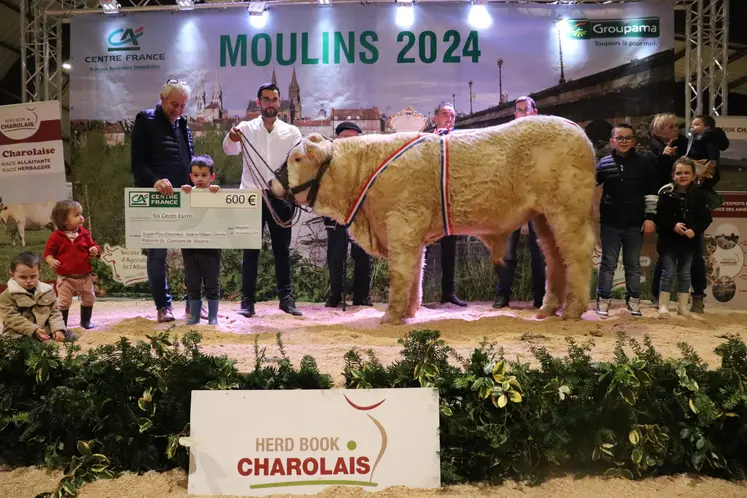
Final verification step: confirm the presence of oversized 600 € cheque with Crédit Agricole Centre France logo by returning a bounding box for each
[125,188,262,249]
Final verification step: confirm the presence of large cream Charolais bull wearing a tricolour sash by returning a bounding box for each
[272,116,596,323]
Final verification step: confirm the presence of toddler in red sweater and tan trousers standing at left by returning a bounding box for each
[44,201,101,329]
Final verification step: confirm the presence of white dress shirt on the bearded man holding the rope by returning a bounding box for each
[223,116,301,190]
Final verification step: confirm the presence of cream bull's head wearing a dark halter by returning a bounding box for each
[270,133,332,207]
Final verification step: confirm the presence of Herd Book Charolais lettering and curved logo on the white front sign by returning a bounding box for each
[236,395,387,489]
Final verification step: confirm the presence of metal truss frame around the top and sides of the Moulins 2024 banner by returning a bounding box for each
[20,0,729,123]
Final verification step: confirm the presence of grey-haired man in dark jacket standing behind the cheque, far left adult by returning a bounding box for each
[131,80,194,322]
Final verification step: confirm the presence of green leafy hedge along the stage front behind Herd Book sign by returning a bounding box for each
[0,330,747,496]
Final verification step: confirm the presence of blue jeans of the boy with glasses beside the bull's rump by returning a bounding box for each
[597,222,643,299]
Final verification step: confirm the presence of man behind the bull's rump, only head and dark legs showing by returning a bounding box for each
[493,96,545,308]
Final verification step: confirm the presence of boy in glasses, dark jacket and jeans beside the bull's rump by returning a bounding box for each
[597,123,658,317]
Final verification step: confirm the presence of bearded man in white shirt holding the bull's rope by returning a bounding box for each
[223,83,302,318]
